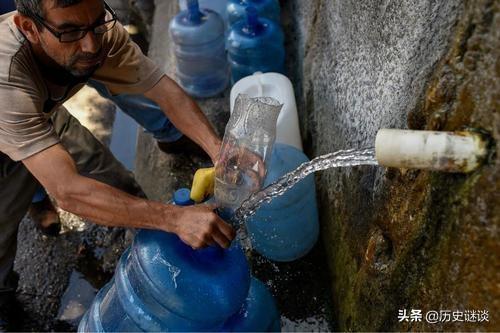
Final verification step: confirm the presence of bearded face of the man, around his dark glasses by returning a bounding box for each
[39,0,105,77]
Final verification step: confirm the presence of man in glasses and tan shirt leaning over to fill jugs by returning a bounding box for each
[0,0,234,326]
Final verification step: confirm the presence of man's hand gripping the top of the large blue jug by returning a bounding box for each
[172,205,236,249]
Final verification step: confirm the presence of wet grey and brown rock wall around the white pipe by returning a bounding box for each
[282,0,500,331]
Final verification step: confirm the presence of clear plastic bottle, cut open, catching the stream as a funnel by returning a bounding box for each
[215,94,282,220]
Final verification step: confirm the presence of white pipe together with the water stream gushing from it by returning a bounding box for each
[233,129,488,225]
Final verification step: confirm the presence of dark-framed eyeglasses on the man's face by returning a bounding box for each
[32,1,117,43]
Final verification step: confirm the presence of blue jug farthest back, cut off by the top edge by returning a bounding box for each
[227,0,280,27]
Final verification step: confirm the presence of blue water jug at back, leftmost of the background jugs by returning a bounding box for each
[170,0,229,97]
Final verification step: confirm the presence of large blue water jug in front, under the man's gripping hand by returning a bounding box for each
[79,191,250,332]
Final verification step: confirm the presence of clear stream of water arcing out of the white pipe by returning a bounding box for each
[232,148,378,225]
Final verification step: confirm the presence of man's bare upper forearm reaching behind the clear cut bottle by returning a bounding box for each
[144,75,221,164]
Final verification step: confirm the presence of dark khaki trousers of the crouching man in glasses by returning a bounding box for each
[0,107,145,305]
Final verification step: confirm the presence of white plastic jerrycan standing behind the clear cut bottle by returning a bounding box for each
[230,72,303,151]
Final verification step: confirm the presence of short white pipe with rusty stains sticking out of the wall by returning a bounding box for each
[375,129,487,172]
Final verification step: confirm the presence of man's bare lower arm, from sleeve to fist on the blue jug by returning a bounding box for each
[23,144,234,248]
